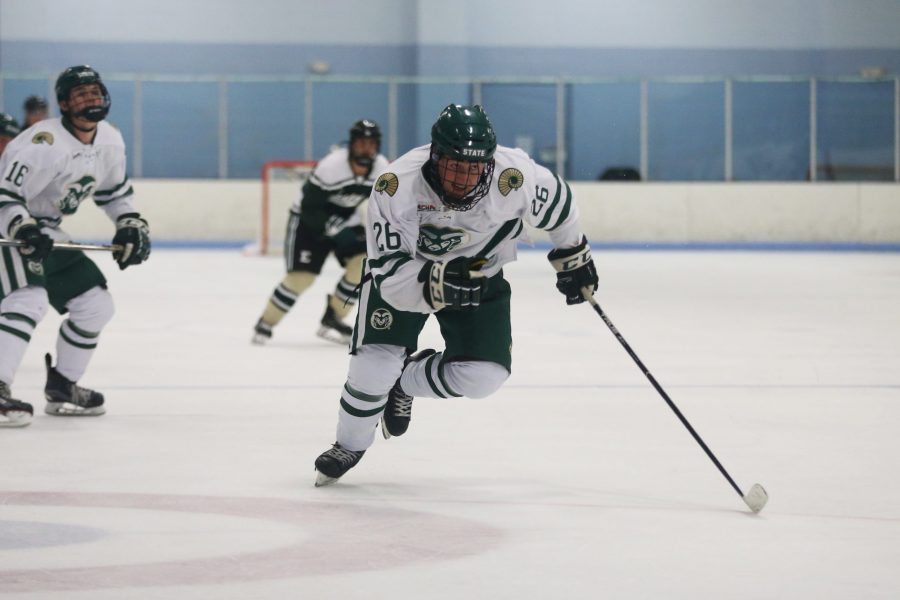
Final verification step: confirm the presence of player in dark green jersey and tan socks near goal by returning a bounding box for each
[252,119,388,344]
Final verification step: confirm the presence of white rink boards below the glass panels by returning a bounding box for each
[59,179,900,244]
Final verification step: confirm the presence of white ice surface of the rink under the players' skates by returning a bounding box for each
[0,250,900,600]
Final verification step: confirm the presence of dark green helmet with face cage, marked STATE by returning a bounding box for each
[425,104,497,211]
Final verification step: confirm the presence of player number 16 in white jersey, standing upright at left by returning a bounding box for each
[0,65,150,426]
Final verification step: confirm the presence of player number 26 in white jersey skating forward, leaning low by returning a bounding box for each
[315,105,598,485]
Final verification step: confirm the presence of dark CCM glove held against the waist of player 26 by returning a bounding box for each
[419,256,487,310]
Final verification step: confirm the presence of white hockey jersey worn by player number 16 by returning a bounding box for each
[0,118,137,240]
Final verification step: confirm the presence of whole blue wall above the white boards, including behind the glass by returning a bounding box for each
[0,0,900,180]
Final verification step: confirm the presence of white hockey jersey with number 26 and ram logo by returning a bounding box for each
[366,146,582,313]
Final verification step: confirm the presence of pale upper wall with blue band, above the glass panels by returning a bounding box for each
[0,0,900,76]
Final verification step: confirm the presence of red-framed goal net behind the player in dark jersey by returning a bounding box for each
[248,160,316,255]
